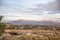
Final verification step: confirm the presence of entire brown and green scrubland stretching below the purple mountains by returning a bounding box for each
[0,17,60,40]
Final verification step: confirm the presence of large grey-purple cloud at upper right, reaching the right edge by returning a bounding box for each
[29,0,60,14]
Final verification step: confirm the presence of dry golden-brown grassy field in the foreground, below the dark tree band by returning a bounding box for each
[2,30,60,40]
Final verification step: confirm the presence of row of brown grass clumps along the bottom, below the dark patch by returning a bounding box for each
[2,33,60,40]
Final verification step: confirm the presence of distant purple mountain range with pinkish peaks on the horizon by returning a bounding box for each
[7,20,60,25]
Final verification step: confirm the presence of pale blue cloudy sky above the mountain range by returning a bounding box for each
[0,0,60,21]
